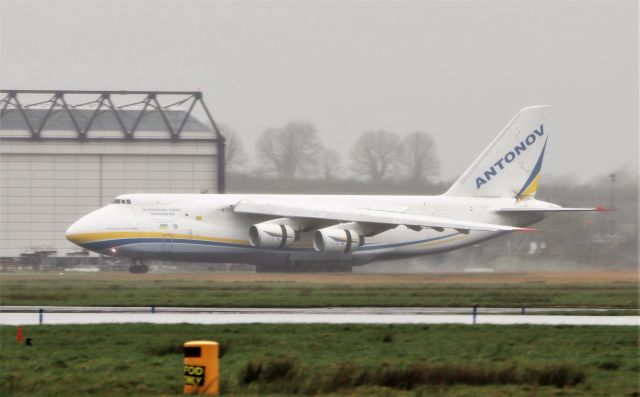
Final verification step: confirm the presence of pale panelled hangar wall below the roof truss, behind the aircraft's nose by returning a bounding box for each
[0,140,217,256]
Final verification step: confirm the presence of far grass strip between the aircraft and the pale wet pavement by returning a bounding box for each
[0,273,638,310]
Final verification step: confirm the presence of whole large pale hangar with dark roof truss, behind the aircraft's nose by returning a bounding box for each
[0,90,224,260]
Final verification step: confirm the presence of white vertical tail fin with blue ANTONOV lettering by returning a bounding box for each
[445,106,551,198]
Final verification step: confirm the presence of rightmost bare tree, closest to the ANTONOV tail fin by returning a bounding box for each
[402,131,440,181]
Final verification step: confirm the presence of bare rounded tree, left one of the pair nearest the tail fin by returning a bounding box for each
[349,130,402,182]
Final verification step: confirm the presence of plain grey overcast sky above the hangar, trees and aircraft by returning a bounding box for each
[0,0,639,180]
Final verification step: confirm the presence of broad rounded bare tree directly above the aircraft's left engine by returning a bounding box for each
[256,121,323,179]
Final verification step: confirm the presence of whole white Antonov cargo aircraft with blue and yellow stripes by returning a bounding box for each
[66,106,602,272]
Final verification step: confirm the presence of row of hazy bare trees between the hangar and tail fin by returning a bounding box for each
[218,121,440,182]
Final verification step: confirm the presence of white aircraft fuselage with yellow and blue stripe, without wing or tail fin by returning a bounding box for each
[66,194,552,264]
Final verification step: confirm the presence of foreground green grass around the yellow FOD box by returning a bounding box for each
[0,324,640,396]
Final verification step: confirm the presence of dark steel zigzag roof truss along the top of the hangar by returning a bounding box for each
[0,90,224,142]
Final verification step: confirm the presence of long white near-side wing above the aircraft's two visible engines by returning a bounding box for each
[234,199,535,232]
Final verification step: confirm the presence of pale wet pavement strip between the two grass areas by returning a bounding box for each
[0,306,640,326]
